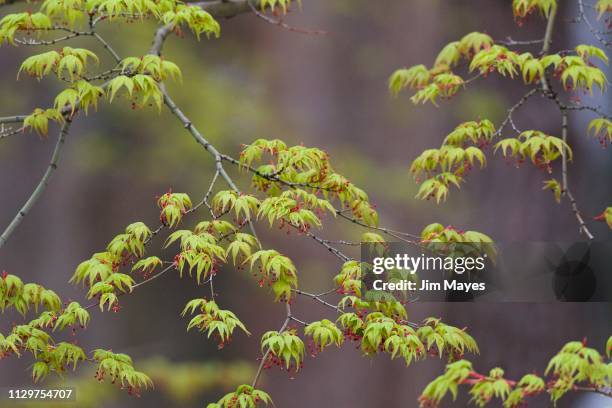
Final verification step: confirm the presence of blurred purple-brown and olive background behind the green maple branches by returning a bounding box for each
[0,0,612,408]
